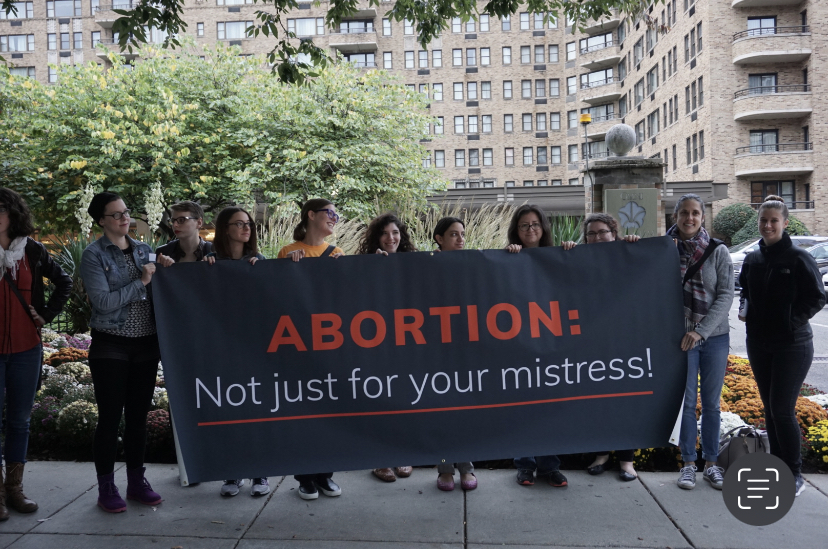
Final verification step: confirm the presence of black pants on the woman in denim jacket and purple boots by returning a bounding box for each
[89,337,158,475]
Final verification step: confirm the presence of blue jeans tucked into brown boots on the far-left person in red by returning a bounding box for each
[0,345,43,463]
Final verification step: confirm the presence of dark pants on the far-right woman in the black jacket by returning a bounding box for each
[747,340,814,476]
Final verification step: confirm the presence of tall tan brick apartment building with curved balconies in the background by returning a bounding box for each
[0,0,828,232]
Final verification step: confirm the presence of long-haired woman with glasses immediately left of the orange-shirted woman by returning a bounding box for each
[204,206,270,497]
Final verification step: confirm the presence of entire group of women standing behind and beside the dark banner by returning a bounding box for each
[0,188,825,520]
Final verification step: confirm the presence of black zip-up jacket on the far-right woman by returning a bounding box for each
[739,233,825,344]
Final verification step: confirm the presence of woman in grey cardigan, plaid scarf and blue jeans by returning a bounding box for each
[667,194,733,490]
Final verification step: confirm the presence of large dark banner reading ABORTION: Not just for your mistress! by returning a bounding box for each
[152,237,686,482]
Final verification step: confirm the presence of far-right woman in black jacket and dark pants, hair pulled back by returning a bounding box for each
[739,195,825,496]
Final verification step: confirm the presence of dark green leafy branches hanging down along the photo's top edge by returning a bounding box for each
[0,0,664,83]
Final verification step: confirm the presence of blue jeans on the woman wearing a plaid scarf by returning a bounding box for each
[679,334,730,463]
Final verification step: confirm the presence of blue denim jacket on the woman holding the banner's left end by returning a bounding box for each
[81,235,152,330]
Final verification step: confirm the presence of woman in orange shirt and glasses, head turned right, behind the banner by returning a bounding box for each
[276,198,344,500]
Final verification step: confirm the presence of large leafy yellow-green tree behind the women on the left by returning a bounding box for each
[0,44,446,232]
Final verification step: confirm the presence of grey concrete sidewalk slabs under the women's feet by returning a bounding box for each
[0,462,828,549]
